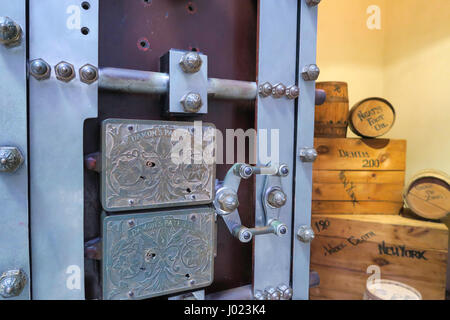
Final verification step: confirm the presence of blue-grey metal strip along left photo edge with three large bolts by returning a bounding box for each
[0,0,30,300]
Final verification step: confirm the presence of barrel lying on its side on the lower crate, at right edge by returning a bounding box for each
[403,170,450,220]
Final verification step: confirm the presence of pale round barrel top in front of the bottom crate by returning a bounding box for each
[364,279,422,300]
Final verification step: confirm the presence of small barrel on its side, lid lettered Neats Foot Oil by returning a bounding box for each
[349,98,395,138]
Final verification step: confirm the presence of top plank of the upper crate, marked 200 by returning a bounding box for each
[313,138,406,171]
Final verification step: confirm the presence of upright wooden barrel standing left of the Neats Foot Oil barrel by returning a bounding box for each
[314,82,349,138]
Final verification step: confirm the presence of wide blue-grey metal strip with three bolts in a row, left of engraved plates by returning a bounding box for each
[29,0,99,299]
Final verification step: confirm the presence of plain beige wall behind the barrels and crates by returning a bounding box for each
[318,0,450,178]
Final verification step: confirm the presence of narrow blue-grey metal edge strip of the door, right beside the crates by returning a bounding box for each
[292,0,317,300]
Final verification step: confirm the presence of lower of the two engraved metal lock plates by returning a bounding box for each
[102,207,215,300]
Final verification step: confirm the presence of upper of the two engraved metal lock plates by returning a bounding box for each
[101,119,216,212]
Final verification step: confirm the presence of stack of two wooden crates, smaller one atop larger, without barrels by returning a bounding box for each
[310,83,448,300]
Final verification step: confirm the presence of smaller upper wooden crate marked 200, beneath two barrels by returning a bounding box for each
[312,138,406,215]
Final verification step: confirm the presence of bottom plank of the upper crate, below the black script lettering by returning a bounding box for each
[311,200,403,215]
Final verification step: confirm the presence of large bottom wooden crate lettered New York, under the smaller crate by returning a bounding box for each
[310,215,448,300]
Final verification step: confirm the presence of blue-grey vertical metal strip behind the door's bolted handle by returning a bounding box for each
[253,0,298,293]
